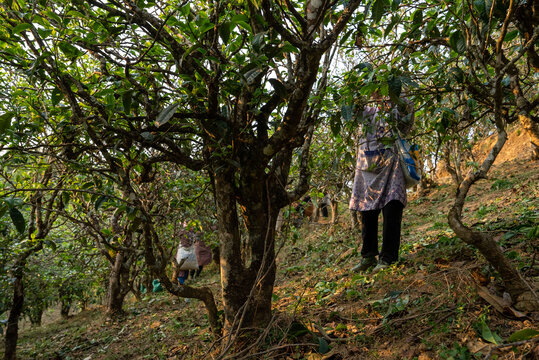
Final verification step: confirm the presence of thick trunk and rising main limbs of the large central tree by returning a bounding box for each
[205,0,359,333]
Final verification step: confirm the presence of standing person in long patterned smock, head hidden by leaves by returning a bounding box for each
[349,93,414,272]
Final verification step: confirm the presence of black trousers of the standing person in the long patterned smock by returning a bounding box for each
[361,200,404,264]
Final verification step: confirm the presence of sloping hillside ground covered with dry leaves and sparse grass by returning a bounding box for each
[7,160,539,360]
